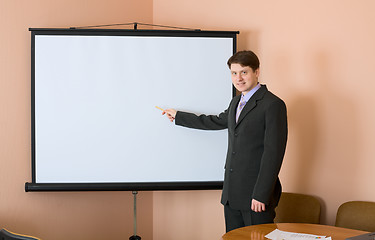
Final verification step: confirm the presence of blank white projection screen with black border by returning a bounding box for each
[25,29,238,191]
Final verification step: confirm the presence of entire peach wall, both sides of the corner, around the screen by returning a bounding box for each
[0,0,375,240]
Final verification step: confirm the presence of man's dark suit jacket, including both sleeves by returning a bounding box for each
[175,85,288,210]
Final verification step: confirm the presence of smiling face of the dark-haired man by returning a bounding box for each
[230,63,259,94]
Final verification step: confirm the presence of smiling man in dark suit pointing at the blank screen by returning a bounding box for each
[163,51,288,232]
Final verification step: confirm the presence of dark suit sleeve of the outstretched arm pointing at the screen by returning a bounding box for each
[175,110,228,130]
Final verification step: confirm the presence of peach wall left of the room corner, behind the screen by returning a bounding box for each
[0,0,152,240]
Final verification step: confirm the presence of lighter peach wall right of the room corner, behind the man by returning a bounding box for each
[153,0,375,240]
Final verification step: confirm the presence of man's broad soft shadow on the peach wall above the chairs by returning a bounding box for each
[288,51,360,223]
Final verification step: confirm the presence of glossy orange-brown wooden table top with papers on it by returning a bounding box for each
[221,223,368,240]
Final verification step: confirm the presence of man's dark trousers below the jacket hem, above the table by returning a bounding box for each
[224,204,276,232]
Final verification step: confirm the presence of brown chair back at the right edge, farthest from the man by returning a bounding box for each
[335,201,375,232]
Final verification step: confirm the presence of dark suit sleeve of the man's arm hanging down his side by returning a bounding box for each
[253,100,288,205]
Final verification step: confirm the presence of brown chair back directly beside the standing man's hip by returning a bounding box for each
[275,192,321,224]
